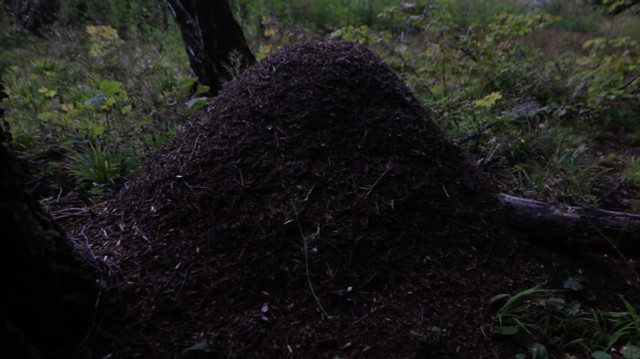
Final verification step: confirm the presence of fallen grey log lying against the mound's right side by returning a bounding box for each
[499,193,640,256]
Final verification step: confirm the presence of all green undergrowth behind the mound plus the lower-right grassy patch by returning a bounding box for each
[0,0,640,359]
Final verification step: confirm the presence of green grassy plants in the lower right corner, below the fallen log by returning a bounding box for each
[490,282,640,359]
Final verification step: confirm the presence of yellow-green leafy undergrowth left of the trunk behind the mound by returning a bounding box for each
[2,11,190,191]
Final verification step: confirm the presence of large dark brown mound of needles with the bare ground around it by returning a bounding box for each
[73,41,639,358]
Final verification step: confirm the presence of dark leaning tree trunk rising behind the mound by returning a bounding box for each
[168,0,256,95]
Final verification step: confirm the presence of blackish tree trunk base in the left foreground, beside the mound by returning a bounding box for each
[0,74,97,359]
